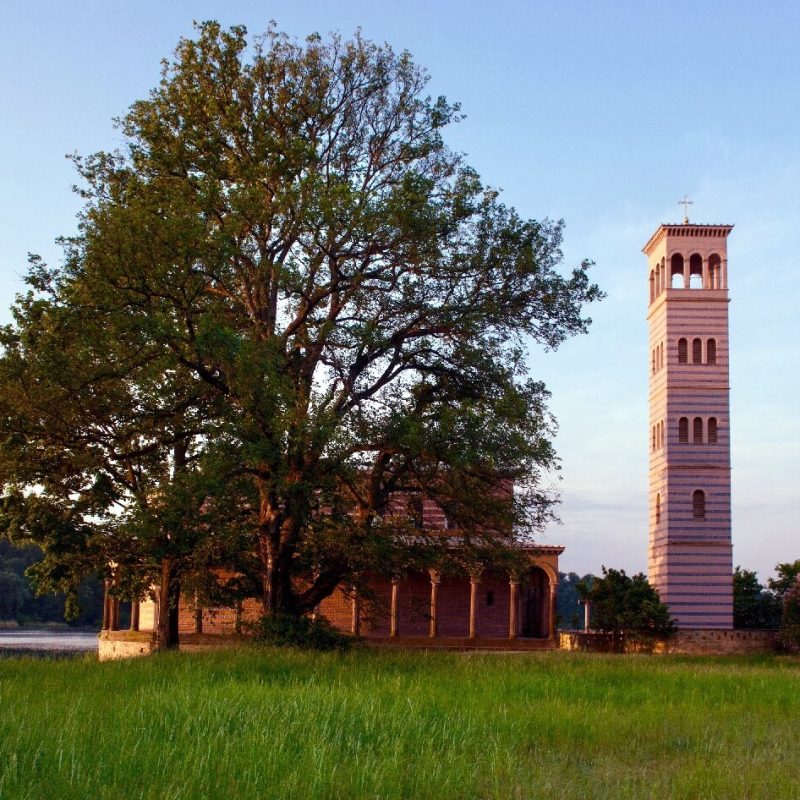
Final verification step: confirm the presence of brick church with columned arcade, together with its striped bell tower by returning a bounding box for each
[107,214,733,649]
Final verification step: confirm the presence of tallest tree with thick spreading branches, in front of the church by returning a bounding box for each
[0,18,600,614]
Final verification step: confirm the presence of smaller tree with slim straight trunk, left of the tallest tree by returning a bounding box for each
[0,266,244,646]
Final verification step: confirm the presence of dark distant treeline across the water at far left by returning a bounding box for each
[0,539,103,628]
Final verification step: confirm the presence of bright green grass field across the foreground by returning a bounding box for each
[0,647,800,800]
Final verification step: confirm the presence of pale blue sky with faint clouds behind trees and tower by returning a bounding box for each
[0,0,800,581]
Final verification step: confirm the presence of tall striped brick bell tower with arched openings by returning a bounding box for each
[643,218,733,629]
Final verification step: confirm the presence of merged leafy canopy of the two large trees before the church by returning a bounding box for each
[0,22,601,640]
